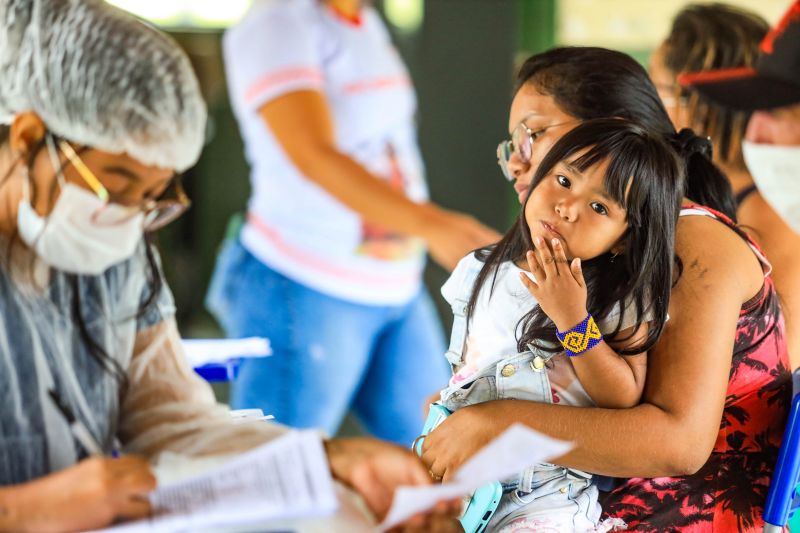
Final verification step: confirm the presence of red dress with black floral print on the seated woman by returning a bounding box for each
[601,206,792,533]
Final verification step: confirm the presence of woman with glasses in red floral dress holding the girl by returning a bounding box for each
[422,48,791,531]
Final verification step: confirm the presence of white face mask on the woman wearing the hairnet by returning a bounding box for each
[17,183,144,275]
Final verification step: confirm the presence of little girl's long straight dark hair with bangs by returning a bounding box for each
[467,118,683,355]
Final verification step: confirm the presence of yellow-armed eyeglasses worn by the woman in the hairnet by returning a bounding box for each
[58,139,192,232]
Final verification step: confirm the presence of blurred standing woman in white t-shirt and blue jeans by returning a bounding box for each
[203,0,498,444]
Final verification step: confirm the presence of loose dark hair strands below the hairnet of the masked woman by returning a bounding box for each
[0,126,163,390]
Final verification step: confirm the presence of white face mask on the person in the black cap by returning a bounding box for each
[742,141,800,233]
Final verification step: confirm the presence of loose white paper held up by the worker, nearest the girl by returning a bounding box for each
[380,424,572,531]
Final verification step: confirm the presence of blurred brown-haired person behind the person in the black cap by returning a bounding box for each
[650,4,800,368]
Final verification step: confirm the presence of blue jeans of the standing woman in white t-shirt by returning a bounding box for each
[206,240,450,446]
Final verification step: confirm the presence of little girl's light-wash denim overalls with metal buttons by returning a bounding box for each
[440,258,601,531]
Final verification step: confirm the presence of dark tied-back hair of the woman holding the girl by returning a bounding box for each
[516,47,736,221]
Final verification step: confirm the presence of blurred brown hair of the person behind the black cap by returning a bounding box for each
[662,4,769,169]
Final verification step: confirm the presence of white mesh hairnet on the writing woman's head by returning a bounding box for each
[0,0,206,171]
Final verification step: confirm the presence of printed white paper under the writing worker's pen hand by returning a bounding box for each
[93,431,338,533]
